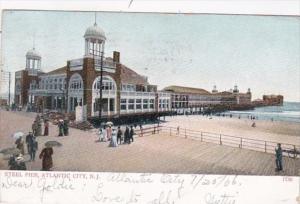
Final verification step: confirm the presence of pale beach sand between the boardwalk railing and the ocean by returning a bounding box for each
[162,115,300,145]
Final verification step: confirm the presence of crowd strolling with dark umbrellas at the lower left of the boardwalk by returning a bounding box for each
[8,115,53,171]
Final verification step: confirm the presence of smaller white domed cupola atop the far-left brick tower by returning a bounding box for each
[25,47,42,74]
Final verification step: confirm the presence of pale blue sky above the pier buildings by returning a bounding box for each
[2,11,300,102]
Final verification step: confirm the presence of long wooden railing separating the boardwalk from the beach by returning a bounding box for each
[136,126,300,158]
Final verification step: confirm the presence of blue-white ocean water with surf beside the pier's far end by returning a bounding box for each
[226,102,300,123]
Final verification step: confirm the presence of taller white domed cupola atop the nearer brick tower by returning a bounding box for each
[84,20,106,58]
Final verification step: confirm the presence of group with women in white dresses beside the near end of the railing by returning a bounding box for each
[99,125,135,147]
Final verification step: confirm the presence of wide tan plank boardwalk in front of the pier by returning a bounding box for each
[0,110,300,176]
